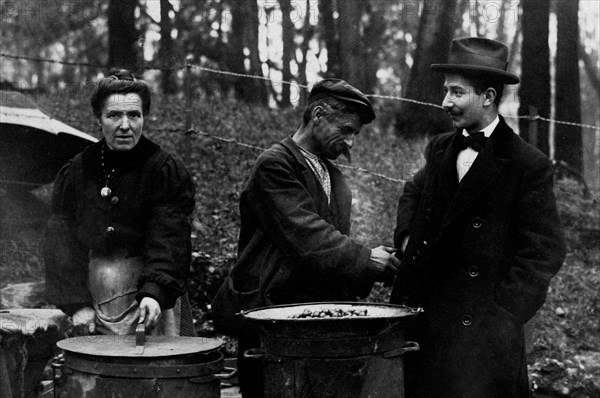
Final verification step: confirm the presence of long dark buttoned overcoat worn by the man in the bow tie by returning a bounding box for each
[391,118,565,398]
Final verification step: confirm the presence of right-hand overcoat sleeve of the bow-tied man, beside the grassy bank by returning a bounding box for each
[495,158,566,322]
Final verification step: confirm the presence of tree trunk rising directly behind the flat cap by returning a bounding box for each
[337,0,368,91]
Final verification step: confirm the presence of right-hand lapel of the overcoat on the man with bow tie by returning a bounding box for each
[442,120,512,229]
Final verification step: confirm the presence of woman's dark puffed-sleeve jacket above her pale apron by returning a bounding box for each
[45,136,195,313]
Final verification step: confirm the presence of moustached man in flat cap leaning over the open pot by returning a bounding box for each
[212,79,399,398]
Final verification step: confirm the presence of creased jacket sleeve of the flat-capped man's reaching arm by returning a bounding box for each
[245,152,374,286]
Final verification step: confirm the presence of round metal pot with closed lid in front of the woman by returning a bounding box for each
[56,335,235,398]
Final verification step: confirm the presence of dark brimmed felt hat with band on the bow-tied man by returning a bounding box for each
[431,37,519,84]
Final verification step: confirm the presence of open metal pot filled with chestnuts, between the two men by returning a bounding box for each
[244,302,420,398]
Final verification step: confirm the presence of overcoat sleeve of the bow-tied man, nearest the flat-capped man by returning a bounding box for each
[394,141,433,253]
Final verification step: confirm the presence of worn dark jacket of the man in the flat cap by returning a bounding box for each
[212,137,374,334]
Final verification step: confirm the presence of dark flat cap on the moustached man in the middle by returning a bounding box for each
[308,79,375,124]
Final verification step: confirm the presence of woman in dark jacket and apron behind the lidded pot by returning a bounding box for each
[45,70,195,335]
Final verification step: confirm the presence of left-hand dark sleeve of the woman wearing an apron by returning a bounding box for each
[44,161,91,315]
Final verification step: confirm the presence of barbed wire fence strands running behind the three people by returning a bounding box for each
[0,53,600,188]
